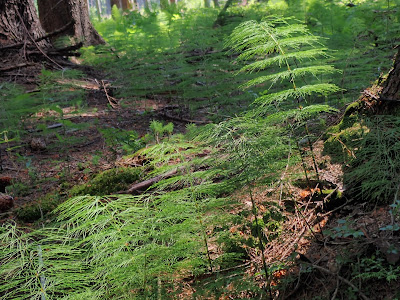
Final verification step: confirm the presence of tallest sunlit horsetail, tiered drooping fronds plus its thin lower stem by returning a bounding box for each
[226,17,340,185]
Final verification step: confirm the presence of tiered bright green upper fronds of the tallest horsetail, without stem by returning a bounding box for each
[226,17,340,115]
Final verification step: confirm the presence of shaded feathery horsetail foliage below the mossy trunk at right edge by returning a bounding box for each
[345,115,400,203]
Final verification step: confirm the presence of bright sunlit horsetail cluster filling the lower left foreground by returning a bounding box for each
[0,137,253,299]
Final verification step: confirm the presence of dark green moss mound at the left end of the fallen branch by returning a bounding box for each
[69,168,141,197]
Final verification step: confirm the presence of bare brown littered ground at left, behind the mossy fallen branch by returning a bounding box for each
[1,70,195,211]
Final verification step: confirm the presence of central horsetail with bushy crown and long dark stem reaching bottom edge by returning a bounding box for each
[197,115,290,296]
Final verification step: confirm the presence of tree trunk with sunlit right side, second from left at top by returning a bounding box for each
[38,0,105,46]
